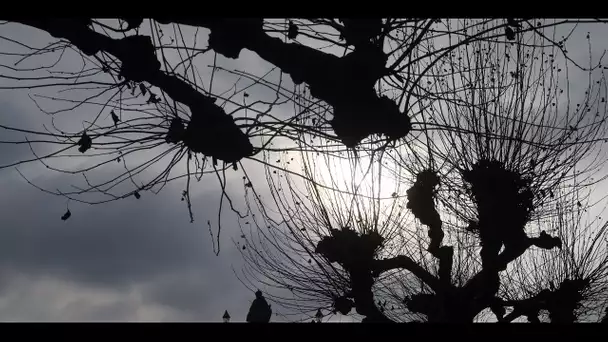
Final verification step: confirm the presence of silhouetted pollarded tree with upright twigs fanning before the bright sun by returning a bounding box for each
[239,20,608,322]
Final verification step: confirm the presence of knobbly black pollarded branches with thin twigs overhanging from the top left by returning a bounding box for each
[1,18,604,246]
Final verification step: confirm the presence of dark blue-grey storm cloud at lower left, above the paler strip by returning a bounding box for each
[0,168,254,320]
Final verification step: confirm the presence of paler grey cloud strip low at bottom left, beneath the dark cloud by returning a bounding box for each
[0,270,251,322]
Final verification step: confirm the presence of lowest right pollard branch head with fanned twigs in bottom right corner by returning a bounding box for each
[499,184,608,323]
